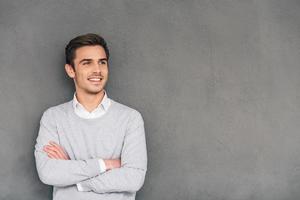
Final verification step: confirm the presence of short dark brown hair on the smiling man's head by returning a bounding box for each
[65,33,109,68]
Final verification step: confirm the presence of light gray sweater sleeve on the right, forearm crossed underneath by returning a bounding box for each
[79,111,147,193]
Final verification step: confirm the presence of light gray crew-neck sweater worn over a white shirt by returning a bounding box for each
[34,100,147,200]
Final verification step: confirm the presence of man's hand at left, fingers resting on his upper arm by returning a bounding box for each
[43,141,70,160]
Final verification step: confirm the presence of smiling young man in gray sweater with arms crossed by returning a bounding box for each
[34,34,147,200]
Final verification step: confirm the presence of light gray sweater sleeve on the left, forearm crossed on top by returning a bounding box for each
[34,109,101,186]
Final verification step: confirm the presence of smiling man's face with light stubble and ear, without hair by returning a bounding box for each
[65,45,108,94]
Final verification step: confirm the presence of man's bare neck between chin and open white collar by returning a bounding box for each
[76,90,104,112]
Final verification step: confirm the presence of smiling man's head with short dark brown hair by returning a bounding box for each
[65,33,109,94]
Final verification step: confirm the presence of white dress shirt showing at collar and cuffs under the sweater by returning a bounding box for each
[73,91,111,191]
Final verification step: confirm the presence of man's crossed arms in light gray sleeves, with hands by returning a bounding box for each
[34,109,147,193]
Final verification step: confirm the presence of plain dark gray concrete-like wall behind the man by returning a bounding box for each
[0,0,300,200]
